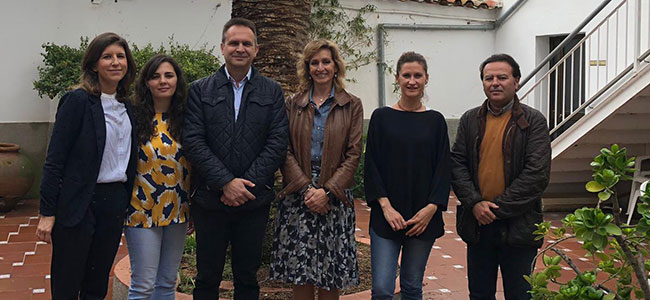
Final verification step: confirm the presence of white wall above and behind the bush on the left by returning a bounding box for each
[0,0,232,123]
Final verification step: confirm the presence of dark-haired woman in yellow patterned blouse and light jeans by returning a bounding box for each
[124,54,190,299]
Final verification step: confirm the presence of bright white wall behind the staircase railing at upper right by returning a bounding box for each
[496,0,650,122]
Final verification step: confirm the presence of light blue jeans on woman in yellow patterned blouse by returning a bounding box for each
[124,223,187,300]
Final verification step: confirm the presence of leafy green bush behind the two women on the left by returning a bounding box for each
[34,37,221,99]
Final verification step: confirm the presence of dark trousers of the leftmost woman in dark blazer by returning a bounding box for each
[51,183,129,300]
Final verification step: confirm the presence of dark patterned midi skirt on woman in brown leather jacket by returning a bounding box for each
[270,170,359,290]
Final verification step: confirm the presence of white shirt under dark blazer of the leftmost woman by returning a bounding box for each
[97,93,131,183]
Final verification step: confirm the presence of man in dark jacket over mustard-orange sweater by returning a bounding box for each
[451,54,551,300]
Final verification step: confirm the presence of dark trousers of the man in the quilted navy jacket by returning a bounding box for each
[191,205,270,300]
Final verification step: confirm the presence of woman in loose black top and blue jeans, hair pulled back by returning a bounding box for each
[365,52,450,300]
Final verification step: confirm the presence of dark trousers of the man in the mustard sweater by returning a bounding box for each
[467,220,537,300]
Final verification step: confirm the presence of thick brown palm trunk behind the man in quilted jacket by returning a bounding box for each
[231,0,311,94]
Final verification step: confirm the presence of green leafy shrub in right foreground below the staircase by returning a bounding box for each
[526,145,650,300]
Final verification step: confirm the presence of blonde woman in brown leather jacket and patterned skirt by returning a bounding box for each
[271,40,363,299]
